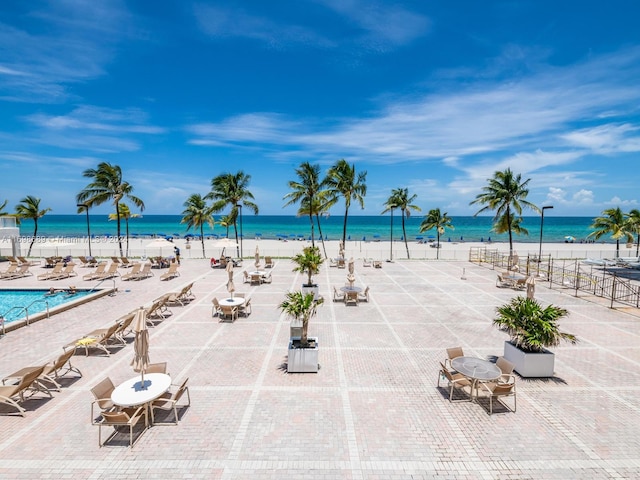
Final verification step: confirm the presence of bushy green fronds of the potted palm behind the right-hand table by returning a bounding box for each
[493,296,578,352]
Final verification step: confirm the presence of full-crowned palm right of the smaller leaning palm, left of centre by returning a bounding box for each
[210,170,258,256]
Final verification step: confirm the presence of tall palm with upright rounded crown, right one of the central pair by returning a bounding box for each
[325,159,367,244]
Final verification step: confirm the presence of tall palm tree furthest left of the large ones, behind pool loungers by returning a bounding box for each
[76,162,144,256]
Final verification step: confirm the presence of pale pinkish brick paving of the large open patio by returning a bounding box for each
[0,259,640,480]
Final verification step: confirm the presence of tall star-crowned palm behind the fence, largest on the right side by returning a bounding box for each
[470,168,540,257]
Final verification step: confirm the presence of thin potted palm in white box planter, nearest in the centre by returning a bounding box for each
[279,291,323,373]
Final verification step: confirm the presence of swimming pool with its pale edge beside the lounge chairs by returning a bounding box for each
[0,289,110,330]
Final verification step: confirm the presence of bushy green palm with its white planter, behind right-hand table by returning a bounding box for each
[493,296,577,377]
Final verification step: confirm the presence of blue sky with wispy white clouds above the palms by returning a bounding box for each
[0,0,640,217]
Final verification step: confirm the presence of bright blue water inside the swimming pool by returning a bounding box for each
[0,290,94,324]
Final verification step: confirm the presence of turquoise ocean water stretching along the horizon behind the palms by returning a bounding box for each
[20,214,600,243]
